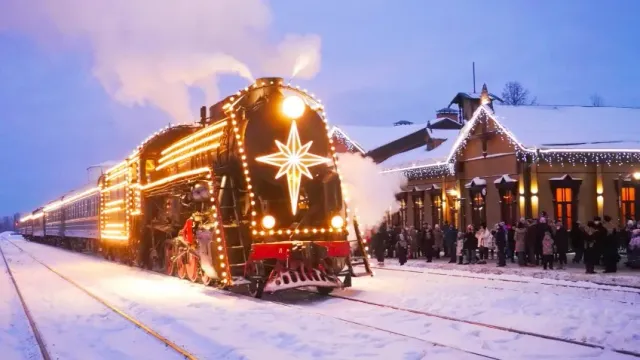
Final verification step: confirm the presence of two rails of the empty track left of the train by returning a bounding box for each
[0,241,197,360]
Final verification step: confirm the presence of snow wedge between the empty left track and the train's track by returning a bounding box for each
[6,239,477,360]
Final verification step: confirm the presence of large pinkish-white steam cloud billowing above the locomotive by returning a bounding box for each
[0,0,320,121]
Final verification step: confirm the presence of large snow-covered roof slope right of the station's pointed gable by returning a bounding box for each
[494,105,640,149]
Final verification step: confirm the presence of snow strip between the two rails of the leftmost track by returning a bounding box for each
[0,240,182,360]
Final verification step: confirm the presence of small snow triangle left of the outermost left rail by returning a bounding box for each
[0,234,42,360]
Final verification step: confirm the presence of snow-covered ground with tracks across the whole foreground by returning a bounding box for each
[0,232,640,360]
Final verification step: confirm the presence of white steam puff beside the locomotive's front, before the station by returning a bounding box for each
[338,153,406,230]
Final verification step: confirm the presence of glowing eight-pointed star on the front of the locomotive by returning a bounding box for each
[256,121,331,215]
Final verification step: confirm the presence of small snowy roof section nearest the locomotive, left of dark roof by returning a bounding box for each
[330,124,427,152]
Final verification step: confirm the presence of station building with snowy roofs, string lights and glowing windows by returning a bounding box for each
[332,85,640,228]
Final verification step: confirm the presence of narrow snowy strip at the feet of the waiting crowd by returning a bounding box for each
[376,254,640,290]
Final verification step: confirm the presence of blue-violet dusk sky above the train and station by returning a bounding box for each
[0,0,640,214]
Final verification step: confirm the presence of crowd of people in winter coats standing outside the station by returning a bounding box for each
[372,212,640,274]
